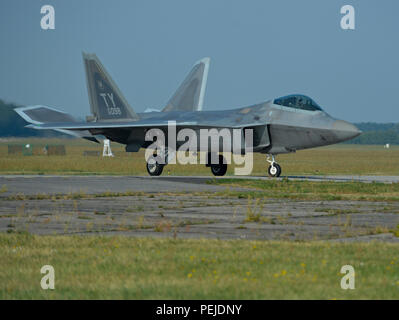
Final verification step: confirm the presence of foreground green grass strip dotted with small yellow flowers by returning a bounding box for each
[0,234,399,299]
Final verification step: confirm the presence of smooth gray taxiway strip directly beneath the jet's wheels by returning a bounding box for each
[0,175,399,196]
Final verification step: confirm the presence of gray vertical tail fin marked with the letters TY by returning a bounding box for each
[83,53,139,121]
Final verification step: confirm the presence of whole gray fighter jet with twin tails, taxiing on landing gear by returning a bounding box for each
[15,53,361,177]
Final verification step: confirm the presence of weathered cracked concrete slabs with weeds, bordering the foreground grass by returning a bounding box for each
[0,193,399,242]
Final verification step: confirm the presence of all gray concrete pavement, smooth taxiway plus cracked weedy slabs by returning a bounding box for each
[0,176,399,242]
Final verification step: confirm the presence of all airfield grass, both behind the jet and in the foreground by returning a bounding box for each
[0,139,399,299]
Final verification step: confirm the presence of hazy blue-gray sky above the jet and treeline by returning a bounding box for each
[0,0,399,122]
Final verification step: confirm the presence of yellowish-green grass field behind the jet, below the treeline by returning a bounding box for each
[0,138,399,176]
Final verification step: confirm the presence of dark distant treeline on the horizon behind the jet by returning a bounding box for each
[0,100,399,145]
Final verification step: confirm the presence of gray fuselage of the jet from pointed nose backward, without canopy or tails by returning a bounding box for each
[119,101,361,154]
